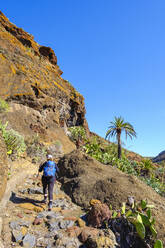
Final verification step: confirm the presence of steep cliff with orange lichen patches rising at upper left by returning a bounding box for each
[0,12,88,151]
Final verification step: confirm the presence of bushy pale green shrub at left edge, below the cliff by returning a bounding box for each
[0,122,26,157]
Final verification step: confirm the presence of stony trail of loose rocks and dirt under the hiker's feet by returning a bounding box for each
[0,160,83,248]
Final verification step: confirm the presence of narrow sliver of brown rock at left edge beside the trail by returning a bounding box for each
[0,133,8,200]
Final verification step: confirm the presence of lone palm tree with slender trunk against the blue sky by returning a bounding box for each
[105,116,136,159]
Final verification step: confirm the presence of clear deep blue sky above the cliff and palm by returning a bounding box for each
[0,0,165,156]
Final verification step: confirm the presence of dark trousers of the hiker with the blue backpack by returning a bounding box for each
[42,176,55,201]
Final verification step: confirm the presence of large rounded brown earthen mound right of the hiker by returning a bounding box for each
[58,150,165,243]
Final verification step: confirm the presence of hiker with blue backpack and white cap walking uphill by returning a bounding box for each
[38,154,59,211]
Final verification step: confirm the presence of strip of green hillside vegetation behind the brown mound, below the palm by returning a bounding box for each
[70,127,165,196]
